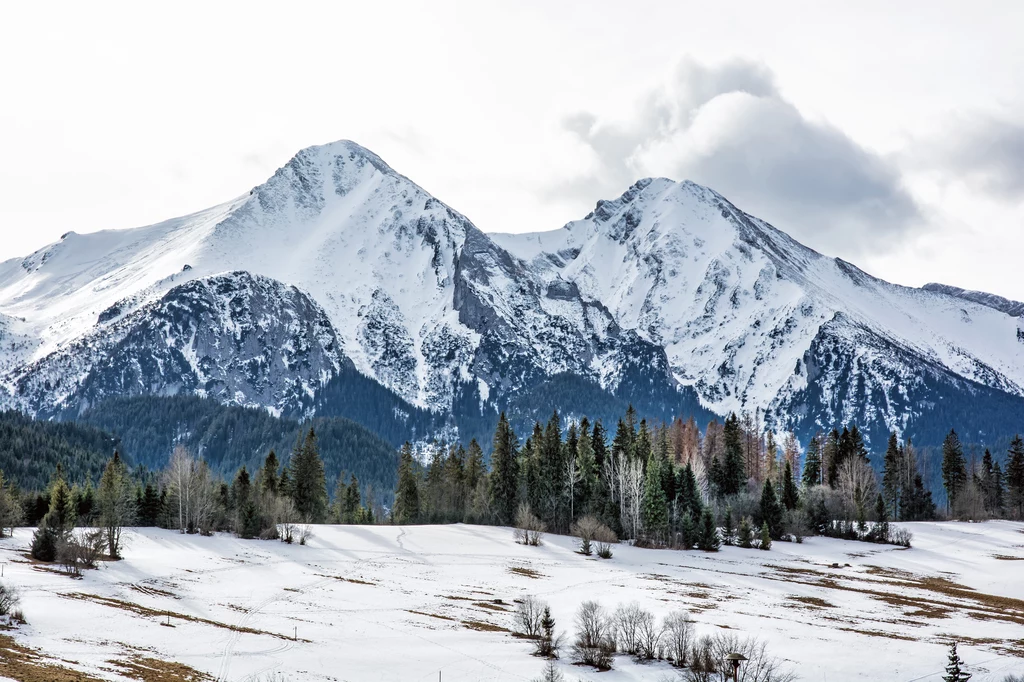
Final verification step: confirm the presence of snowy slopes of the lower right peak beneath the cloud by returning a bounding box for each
[493,179,1024,427]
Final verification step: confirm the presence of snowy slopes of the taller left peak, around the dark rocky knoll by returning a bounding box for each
[0,141,671,412]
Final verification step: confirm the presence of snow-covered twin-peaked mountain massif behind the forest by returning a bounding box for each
[0,141,1024,444]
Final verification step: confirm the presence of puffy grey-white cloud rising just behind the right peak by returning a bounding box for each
[559,59,923,254]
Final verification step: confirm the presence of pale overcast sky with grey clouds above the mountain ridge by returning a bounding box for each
[0,0,1024,299]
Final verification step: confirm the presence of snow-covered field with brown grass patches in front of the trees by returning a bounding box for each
[0,521,1024,682]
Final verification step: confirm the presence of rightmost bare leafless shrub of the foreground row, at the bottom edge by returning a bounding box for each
[683,633,797,682]
